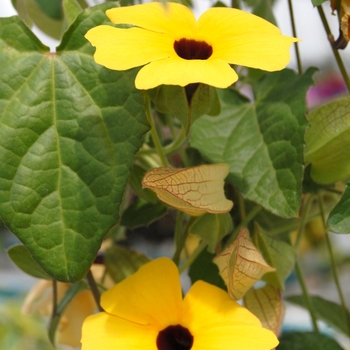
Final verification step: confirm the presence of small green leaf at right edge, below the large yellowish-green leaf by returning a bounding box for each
[327,185,350,233]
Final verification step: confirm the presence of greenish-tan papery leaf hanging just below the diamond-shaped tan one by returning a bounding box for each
[243,284,285,336]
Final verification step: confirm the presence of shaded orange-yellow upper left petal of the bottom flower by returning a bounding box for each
[101,258,182,329]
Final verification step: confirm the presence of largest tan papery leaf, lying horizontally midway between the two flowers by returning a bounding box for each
[142,164,233,216]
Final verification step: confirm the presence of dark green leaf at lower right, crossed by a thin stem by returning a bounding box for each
[286,295,350,335]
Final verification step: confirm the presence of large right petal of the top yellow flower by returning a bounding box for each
[198,8,298,71]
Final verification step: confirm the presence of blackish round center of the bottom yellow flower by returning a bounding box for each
[157,324,193,350]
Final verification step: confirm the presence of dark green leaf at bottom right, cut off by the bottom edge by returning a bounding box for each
[276,332,343,350]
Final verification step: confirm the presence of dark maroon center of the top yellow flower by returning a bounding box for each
[174,39,213,60]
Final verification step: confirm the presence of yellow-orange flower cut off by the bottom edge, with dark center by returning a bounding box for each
[82,258,278,350]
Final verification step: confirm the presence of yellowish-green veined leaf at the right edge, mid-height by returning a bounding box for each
[305,97,350,184]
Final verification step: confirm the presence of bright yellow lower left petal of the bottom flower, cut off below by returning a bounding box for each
[81,312,159,350]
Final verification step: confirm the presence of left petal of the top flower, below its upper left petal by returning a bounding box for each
[85,25,174,70]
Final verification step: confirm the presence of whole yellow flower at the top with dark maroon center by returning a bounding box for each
[85,2,298,89]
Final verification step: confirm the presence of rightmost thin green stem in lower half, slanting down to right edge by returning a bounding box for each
[318,193,350,335]
